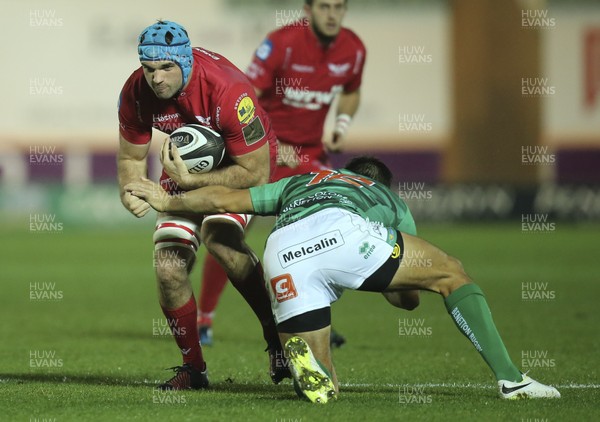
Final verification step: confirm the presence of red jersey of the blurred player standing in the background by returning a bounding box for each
[246,21,366,147]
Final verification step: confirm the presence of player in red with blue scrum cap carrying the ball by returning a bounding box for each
[118,21,290,389]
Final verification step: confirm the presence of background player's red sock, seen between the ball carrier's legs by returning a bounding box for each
[198,255,232,326]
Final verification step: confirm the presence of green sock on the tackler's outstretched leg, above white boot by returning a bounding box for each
[444,284,523,382]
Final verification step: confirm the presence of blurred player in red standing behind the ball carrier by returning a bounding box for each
[198,0,366,345]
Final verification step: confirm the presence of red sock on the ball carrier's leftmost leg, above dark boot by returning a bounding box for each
[161,295,206,371]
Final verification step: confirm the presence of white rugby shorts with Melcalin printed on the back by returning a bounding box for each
[263,208,394,324]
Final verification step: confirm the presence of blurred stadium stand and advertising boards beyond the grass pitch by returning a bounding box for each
[0,0,600,227]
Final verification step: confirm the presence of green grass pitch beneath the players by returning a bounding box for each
[0,221,600,421]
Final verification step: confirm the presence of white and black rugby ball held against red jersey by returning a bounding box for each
[169,125,225,173]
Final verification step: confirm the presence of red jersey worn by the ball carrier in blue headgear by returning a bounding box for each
[119,47,277,180]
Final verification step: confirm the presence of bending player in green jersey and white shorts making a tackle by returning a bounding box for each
[126,157,560,403]
